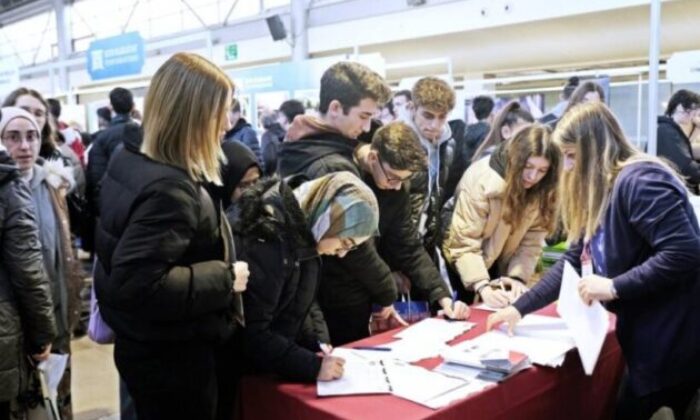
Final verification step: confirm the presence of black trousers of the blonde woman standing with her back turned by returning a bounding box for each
[114,338,240,420]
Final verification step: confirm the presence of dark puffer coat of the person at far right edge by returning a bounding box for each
[656,116,700,193]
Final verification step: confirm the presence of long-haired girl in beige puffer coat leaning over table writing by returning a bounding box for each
[443,124,560,307]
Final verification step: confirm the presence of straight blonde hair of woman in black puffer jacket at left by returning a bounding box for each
[141,53,234,185]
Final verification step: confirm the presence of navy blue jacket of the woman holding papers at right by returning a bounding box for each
[514,162,700,396]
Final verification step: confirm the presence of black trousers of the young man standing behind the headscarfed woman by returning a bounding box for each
[321,303,372,346]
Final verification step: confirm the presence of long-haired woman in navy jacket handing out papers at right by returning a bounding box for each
[487,103,700,419]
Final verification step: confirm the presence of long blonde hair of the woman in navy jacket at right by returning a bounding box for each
[554,103,675,242]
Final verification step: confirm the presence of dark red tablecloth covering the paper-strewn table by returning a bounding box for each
[240,306,624,420]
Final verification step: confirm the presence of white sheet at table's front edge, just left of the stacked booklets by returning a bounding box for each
[385,361,466,405]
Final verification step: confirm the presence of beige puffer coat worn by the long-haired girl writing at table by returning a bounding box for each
[443,158,547,288]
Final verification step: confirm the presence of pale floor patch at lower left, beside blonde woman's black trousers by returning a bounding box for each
[71,336,119,420]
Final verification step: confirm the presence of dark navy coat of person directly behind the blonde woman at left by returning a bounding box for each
[86,114,138,214]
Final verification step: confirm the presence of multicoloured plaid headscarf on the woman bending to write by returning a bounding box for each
[294,172,379,242]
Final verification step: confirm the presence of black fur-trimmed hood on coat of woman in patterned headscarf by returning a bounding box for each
[226,177,316,249]
